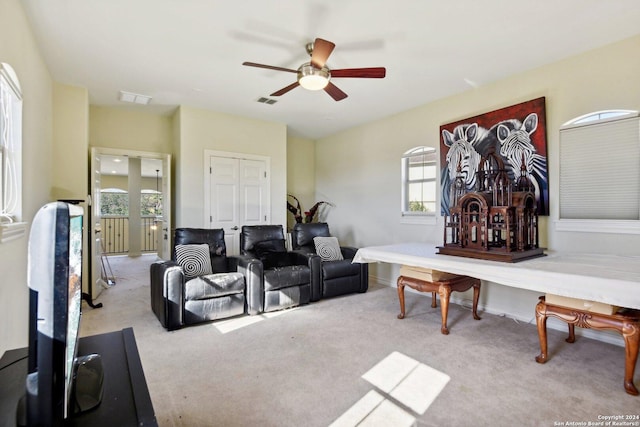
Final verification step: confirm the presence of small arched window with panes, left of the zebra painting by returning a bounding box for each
[402,147,437,217]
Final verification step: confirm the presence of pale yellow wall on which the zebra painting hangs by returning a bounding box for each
[316,36,640,320]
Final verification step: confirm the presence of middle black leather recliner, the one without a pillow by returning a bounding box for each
[240,225,319,312]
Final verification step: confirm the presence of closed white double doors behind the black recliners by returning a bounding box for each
[205,154,270,255]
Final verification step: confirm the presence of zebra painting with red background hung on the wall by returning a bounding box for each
[440,97,549,215]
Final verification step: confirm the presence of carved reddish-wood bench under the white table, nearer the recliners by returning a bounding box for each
[398,276,480,335]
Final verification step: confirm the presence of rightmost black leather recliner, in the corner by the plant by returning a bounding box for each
[291,222,369,298]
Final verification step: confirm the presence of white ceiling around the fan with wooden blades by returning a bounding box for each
[22,0,640,139]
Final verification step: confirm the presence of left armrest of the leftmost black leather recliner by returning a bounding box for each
[150,261,184,330]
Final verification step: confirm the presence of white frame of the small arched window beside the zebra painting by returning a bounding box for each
[400,146,438,224]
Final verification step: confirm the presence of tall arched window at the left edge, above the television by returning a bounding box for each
[0,63,26,242]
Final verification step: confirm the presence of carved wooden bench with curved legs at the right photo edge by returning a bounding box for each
[536,297,640,396]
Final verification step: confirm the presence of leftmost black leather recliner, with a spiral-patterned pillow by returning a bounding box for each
[150,228,262,330]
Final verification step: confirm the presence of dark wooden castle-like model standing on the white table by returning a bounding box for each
[438,152,544,262]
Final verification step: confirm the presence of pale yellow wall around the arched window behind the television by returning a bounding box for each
[0,0,53,354]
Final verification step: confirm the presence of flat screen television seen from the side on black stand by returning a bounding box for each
[17,202,103,427]
